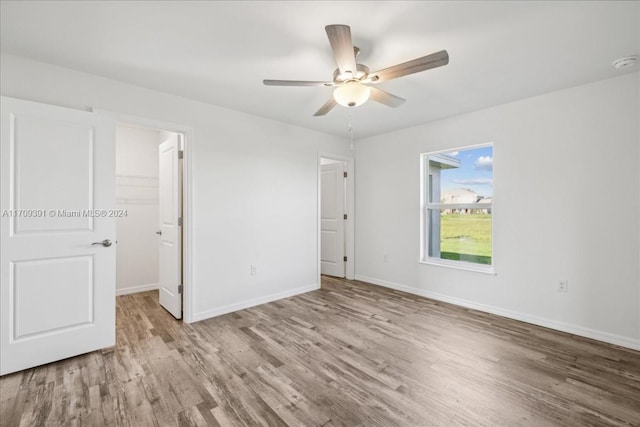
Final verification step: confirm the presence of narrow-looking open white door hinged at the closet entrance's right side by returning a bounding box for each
[159,134,182,319]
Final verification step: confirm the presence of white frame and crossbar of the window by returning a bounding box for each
[419,142,496,274]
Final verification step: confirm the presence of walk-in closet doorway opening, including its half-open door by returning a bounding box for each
[115,123,185,319]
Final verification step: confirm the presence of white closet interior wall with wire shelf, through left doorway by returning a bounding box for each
[116,125,162,295]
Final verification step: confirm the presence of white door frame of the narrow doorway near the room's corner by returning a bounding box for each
[317,151,356,287]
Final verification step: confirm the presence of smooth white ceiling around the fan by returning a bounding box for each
[0,1,640,138]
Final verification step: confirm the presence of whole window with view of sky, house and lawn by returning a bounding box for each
[421,144,493,272]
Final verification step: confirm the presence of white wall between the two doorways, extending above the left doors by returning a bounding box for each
[0,55,350,320]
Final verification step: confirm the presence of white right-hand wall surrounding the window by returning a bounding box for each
[356,73,640,349]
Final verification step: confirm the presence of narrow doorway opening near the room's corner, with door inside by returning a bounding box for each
[318,154,355,283]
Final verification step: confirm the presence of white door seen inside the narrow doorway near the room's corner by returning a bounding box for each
[320,163,345,277]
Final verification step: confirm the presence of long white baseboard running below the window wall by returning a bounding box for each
[356,274,640,350]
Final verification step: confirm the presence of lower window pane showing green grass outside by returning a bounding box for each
[427,208,492,265]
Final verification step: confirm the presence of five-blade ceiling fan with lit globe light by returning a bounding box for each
[263,25,449,116]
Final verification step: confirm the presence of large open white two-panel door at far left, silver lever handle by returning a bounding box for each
[0,97,116,375]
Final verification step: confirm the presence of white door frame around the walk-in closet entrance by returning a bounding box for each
[94,109,194,323]
